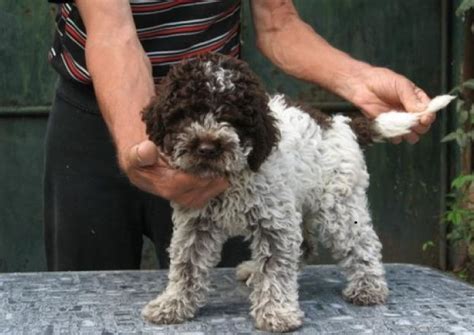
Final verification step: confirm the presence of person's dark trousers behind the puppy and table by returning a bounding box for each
[44,80,249,271]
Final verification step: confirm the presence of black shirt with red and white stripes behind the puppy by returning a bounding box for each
[49,0,240,84]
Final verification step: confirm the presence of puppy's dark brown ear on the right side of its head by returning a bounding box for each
[247,101,280,172]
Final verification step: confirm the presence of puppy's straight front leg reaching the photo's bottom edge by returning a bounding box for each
[250,208,304,332]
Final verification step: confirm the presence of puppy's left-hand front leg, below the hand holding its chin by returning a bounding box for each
[142,218,225,324]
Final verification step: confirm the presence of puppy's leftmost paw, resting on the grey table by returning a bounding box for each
[142,295,195,324]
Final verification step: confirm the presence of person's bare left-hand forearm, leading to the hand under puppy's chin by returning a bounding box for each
[76,0,154,167]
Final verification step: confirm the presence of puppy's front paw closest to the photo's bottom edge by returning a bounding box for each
[255,308,304,333]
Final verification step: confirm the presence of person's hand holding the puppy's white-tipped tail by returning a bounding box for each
[347,66,436,144]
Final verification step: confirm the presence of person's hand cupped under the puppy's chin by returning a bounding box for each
[119,141,229,208]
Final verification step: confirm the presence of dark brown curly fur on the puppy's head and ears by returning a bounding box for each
[143,54,279,171]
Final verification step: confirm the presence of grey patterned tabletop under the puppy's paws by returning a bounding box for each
[0,264,474,335]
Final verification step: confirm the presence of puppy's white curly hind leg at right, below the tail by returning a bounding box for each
[315,186,388,305]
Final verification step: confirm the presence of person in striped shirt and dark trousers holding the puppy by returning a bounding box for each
[44,0,434,271]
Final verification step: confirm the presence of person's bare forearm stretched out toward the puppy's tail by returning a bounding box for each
[252,0,370,100]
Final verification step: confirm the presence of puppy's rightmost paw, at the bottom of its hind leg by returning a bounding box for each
[342,277,388,306]
